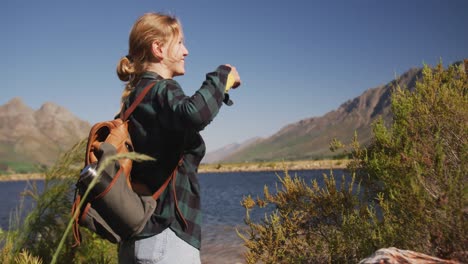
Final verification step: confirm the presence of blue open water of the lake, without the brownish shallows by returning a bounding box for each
[0,170,342,230]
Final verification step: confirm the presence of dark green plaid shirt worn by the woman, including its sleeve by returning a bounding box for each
[125,66,232,249]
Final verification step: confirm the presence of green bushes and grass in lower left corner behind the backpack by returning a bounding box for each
[0,141,117,263]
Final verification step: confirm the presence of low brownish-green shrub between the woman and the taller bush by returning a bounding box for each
[239,172,387,263]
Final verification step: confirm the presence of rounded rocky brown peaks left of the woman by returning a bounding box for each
[0,98,90,171]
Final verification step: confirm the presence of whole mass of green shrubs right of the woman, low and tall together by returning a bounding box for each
[239,61,468,263]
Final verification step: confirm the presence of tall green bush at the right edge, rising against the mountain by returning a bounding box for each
[353,64,468,258]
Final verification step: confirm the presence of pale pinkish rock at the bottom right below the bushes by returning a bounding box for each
[359,247,461,264]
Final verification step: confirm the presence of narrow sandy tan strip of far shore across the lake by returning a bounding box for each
[0,160,349,182]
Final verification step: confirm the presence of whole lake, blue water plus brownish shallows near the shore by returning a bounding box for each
[0,170,343,263]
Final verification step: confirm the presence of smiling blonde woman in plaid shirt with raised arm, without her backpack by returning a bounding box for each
[117,13,240,263]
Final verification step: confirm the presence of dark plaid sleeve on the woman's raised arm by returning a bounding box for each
[156,65,231,131]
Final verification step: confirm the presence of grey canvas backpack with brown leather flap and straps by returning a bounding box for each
[72,82,180,245]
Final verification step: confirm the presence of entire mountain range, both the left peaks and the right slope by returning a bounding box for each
[0,63,450,171]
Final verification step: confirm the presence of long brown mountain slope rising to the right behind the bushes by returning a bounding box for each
[218,69,421,162]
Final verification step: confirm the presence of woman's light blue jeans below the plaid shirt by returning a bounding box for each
[119,228,201,264]
